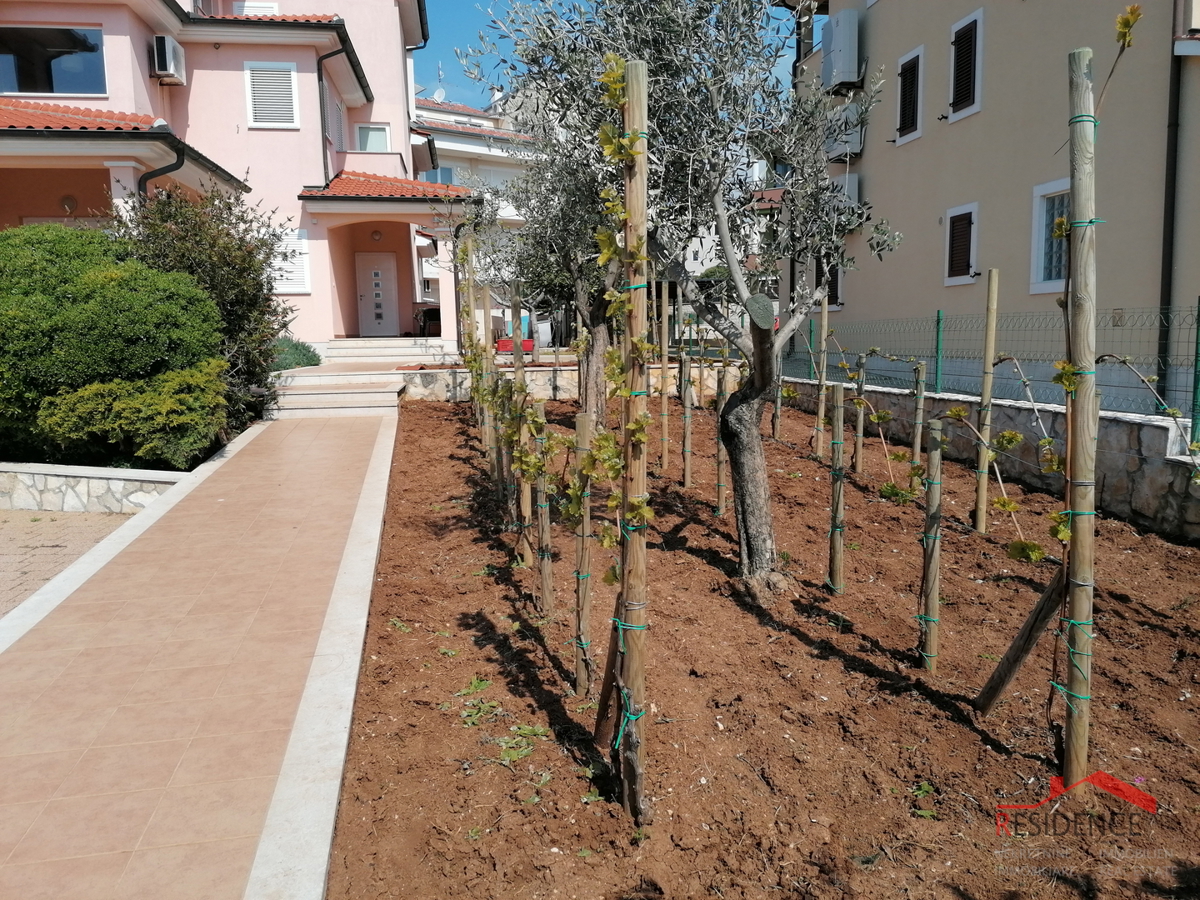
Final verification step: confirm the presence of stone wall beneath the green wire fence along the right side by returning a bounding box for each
[784,378,1200,540]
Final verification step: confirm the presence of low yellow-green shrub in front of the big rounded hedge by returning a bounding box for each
[37,359,226,469]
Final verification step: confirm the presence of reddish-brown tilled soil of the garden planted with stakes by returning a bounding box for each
[329,403,1200,900]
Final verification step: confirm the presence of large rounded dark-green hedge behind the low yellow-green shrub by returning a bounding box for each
[0,224,223,468]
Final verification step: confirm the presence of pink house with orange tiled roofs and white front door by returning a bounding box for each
[0,0,469,358]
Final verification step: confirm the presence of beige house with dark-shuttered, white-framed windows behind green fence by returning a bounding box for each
[797,0,1200,338]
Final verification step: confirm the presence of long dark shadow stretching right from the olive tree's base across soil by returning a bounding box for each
[731,583,1055,766]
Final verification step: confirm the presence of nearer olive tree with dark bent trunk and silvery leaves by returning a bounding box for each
[472,0,898,578]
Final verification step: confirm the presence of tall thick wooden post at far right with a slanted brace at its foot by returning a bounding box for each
[1062,47,1099,785]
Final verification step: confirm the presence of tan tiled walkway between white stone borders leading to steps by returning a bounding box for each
[0,418,395,900]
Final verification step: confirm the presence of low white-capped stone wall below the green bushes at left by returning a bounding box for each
[0,462,186,514]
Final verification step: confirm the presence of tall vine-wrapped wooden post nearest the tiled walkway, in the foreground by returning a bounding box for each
[613,60,650,824]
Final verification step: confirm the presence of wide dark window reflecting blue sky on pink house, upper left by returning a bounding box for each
[0,28,107,94]
